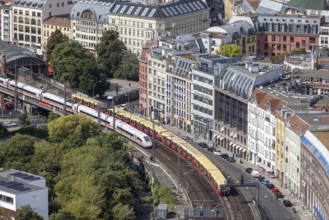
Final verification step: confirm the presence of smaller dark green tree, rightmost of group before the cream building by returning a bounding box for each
[114,51,139,81]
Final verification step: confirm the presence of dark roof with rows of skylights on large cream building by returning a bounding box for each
[110,0,208,18]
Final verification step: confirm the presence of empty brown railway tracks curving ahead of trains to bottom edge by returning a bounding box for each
[149,141,254,220]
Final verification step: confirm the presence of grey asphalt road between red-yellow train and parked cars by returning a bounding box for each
[190,144,299,220]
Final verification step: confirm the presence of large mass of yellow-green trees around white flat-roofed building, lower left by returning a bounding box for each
[0,115,141,220]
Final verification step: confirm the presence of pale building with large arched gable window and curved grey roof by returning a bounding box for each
[70,0,113,53]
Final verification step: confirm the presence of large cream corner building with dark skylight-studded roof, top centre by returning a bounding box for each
[108,0,210,54]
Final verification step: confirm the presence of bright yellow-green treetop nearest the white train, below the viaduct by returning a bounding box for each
[48,115,102,148]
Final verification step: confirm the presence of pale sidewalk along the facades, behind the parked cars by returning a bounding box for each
[163,124,314,220]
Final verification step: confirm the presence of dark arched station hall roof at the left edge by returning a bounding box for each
[0,41,45,69]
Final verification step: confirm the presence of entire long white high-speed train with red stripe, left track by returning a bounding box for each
[0,77,152,148]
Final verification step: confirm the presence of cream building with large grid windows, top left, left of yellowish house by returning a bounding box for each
[11,0,73,53]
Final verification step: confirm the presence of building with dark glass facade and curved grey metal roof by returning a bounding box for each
[214,63,283,159]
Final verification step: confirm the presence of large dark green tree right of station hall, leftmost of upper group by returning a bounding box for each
[50,40,108,95]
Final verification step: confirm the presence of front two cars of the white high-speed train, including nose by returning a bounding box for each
[72,103,152,148]
